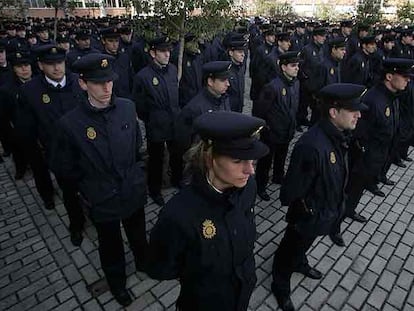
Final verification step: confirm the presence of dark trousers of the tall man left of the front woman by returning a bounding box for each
[95,208,148,294]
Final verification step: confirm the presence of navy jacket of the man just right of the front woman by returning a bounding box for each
[280,120,348,237]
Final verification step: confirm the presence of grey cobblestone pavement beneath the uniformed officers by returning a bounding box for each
[0,71,414,311]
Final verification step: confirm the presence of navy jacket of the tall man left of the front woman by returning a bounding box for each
[53,96,146,222]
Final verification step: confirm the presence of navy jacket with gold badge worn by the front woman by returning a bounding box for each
[148,176,256,311]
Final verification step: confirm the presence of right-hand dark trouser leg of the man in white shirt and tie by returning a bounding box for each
[56,176,85,232]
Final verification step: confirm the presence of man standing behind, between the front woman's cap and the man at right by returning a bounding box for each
[256,51,299,201]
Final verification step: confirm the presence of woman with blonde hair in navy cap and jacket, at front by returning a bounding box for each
[147,111,268,311]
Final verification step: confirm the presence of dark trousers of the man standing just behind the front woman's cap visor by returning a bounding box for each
[256,143,289,191]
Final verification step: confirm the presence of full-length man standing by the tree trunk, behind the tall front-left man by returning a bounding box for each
[133,36,182,206]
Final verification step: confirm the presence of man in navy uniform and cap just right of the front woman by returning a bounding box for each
[272,84,366,311]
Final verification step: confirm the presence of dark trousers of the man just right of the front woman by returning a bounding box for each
[272,225,315,295]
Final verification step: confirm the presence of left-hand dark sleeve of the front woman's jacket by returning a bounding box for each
[147,203,188,280]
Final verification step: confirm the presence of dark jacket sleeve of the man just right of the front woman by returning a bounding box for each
[280,145,319,206]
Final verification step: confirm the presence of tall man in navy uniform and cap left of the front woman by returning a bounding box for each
[56,53,147,306]
